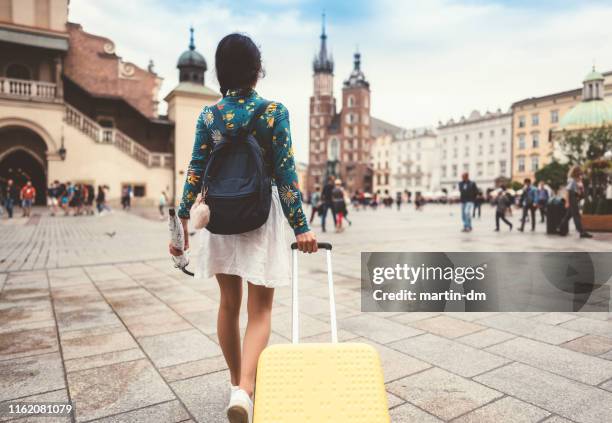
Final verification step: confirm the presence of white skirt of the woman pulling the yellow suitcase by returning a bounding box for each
[195,186,291,288]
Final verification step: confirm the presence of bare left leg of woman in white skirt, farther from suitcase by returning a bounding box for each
[215,274,242,386]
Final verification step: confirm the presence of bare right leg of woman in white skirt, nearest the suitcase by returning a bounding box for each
[240,282,274,395]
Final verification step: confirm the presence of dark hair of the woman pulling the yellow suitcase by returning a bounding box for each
[215,33,262,96]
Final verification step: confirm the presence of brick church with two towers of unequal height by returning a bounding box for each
[306,17,372,194]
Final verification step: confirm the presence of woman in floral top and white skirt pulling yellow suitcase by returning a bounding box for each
[170,34,317,423]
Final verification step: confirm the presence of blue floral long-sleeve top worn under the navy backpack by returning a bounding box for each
[178,90,310,235]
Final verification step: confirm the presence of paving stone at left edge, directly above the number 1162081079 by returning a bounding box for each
[0,353,65,400]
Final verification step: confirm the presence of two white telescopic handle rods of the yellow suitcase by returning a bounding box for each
[291,242,338,344]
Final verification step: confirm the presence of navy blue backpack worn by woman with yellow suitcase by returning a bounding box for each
[202,102,272,235]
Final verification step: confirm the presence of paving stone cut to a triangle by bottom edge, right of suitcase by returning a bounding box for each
[453,397,550,423]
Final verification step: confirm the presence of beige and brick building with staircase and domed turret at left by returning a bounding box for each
[0,0,220,204]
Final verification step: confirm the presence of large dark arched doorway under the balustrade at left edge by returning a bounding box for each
[0,127,47,205]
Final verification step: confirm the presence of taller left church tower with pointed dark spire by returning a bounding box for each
[306,14,339,192]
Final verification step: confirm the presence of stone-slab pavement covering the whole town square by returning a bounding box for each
[0,206,612,423]
